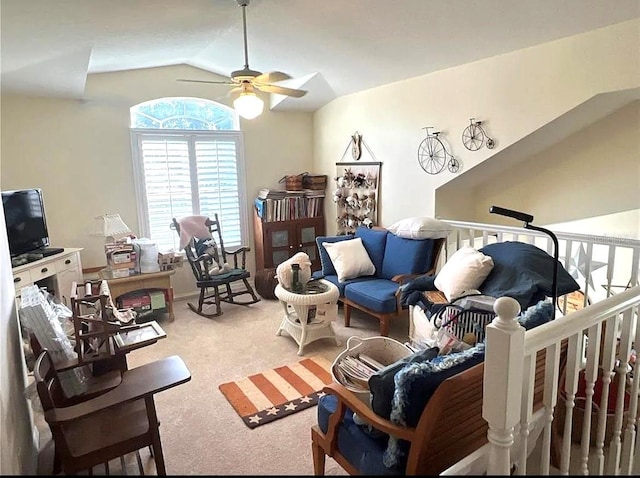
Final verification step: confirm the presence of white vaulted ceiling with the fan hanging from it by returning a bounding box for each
[0,0,640,111]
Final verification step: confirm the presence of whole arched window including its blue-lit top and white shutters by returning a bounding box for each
[130,98,248,251]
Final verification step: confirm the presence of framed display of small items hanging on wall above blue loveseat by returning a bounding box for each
[333,162,382,235]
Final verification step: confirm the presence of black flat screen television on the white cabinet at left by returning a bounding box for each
[2,188,49,257]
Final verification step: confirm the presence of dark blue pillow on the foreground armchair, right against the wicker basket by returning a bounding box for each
[369,347,439,420]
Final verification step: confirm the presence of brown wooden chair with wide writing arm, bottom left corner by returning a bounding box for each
[34,349,191,475]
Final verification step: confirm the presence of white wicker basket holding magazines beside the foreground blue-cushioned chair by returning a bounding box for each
[331,336,412,404]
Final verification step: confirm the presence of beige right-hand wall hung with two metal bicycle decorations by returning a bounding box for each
[314,20,640,232]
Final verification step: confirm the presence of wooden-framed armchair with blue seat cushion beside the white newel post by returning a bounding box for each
[311,343,566,476]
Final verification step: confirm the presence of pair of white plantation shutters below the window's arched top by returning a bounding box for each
[132,130,247,251]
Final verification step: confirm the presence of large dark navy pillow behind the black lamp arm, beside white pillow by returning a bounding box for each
[478,241,580,310]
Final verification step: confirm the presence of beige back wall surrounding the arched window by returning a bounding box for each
[1,65,313,296]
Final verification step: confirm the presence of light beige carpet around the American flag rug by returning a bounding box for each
[39,292,409,475]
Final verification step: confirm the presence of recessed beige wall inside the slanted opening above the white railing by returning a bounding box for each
[472,101,640,230]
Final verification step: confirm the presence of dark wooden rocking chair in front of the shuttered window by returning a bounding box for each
[171,213,260,317]
